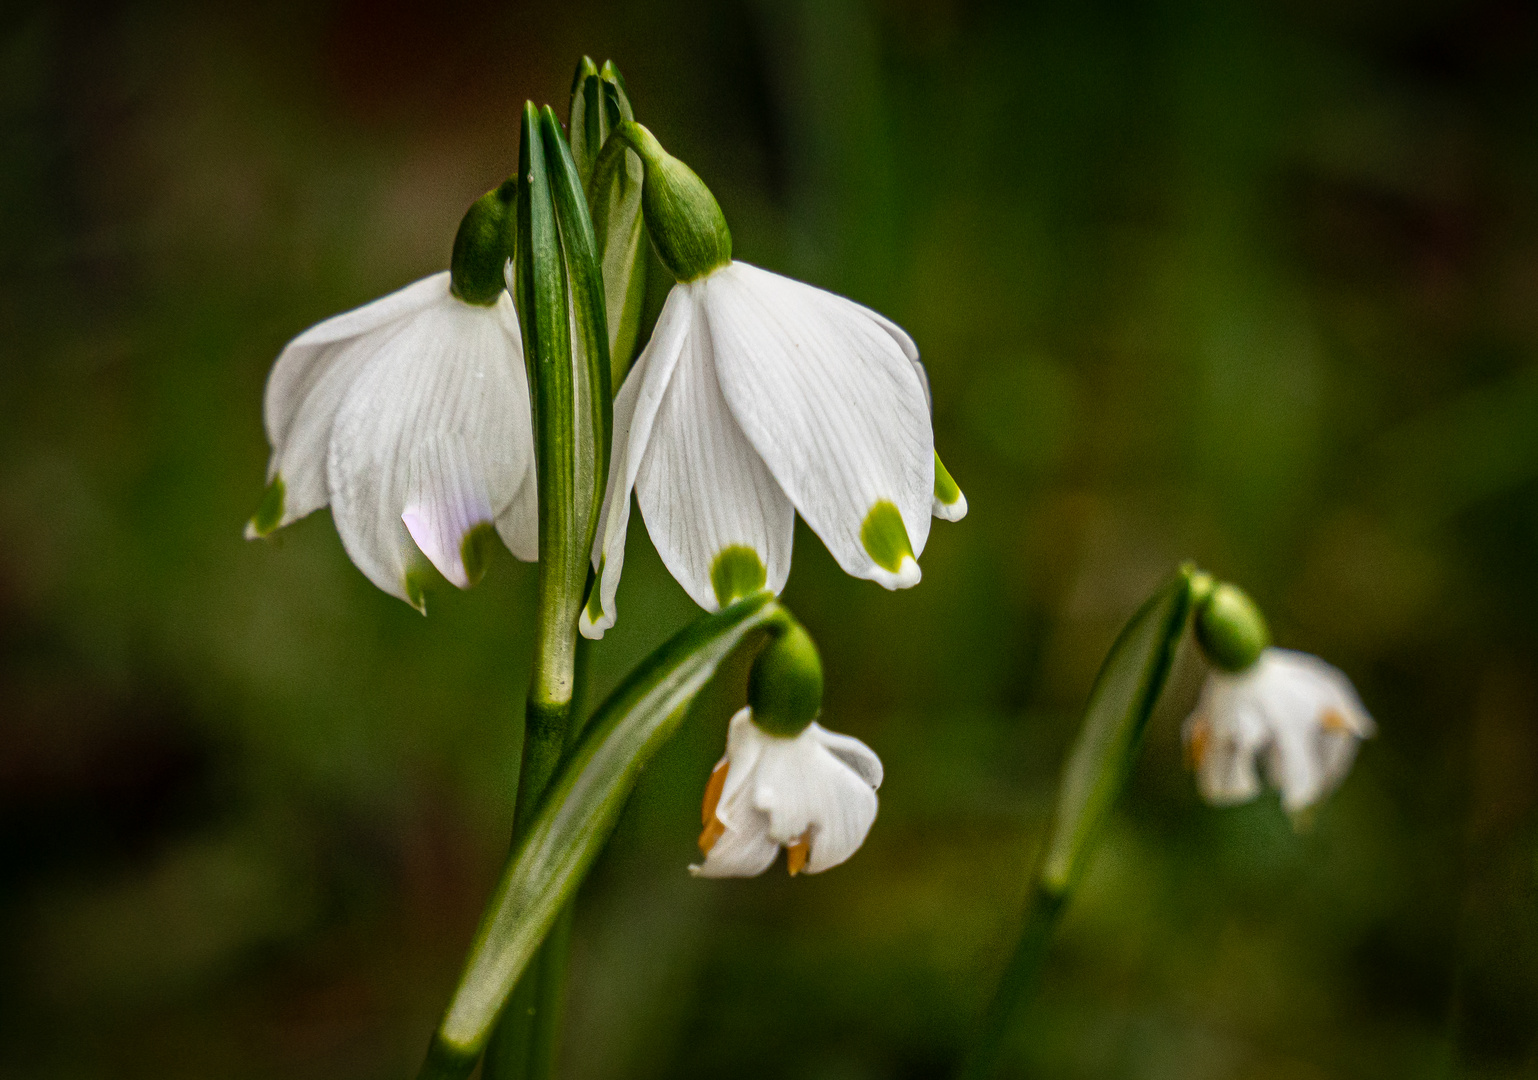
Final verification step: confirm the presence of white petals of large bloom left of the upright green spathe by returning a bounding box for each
[246,271,538,608]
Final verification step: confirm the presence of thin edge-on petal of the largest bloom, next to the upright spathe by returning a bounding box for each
[578,285,694,638]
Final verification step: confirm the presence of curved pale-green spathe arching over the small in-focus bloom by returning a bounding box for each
[421,592,789,1077]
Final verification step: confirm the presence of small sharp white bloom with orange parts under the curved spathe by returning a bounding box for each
[689,708,881,877]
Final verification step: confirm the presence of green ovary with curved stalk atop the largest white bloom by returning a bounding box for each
[597,120,732,283]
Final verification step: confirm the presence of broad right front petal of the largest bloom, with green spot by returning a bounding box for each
[700,263,935,588]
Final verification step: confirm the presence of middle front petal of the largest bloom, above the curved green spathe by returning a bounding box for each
[635,287,795,611]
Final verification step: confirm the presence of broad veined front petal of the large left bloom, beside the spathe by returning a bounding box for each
[328,294,534,600]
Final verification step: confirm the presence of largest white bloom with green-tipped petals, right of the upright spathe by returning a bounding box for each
[581,262,966,637]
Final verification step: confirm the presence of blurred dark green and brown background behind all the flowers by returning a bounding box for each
[0,0,1538,1080]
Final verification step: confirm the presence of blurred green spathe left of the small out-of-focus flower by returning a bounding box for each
[1040,563,1197,895]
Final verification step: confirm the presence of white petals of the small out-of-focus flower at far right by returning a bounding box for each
[1184,648,1375,814]
